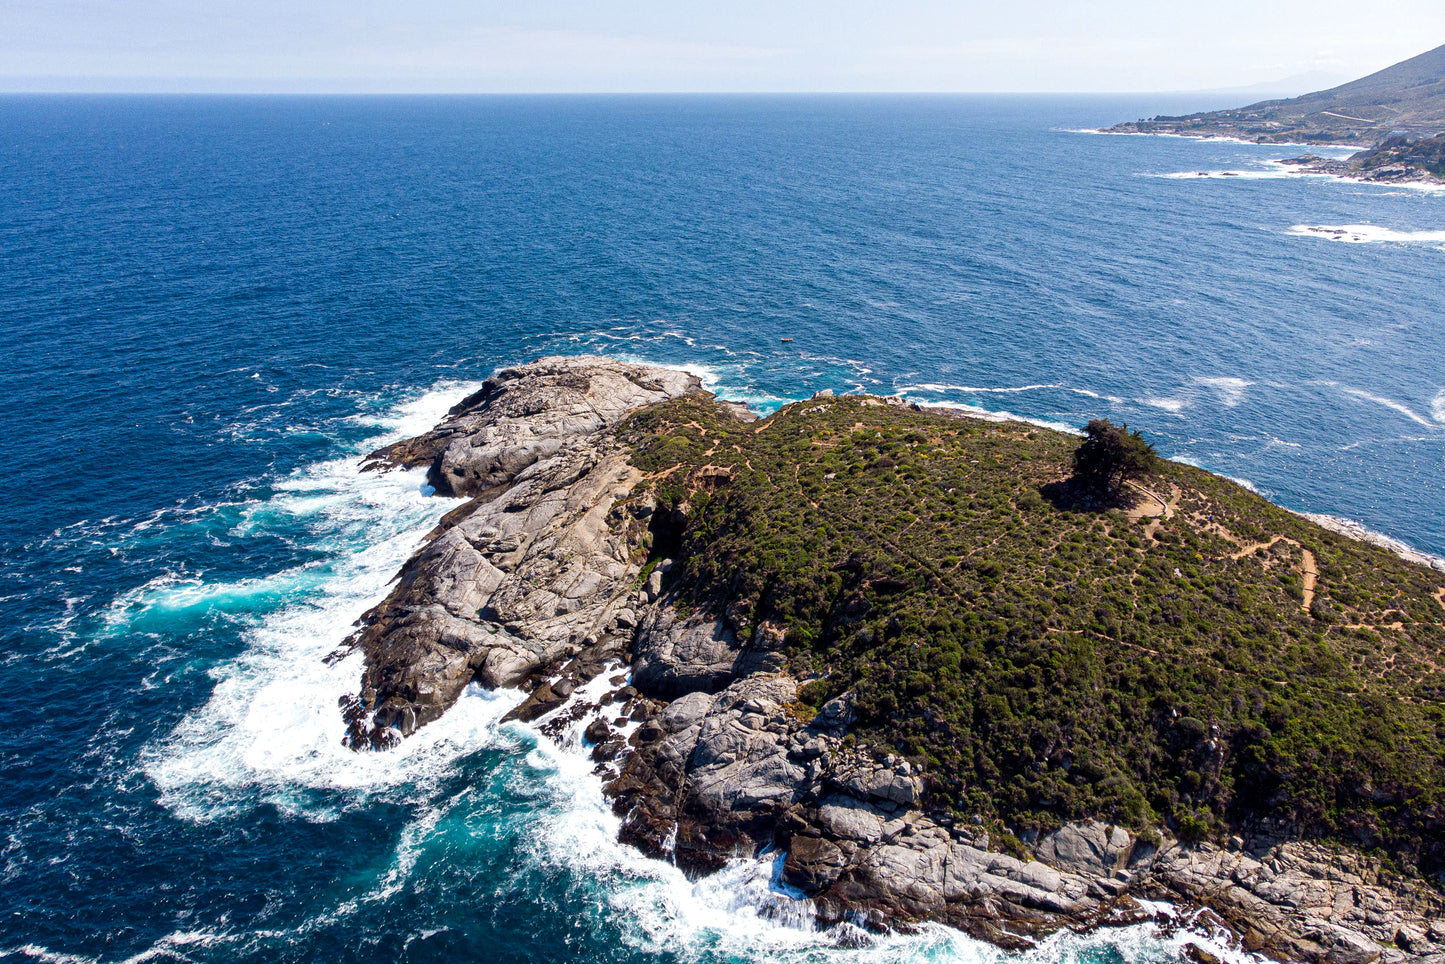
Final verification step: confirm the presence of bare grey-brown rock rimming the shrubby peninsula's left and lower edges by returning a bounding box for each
[338,357,1445,964]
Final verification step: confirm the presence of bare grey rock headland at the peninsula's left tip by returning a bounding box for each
[344,357,701,747]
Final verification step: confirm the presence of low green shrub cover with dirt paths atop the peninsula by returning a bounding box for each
[624,396,1445,873]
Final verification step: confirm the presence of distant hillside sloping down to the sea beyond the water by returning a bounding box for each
[1110,46,1445,145]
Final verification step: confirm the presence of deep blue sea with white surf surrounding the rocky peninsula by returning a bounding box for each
[0,97,1445,964]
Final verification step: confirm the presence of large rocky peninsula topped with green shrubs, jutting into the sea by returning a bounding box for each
[332,357,1445,964]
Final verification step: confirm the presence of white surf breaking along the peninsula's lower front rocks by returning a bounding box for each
[504,679,1259,964]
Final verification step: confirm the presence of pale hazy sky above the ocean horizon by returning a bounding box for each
[0,0,1445,91]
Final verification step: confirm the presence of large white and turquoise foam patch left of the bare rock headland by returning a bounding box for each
[141,383,502,819]
